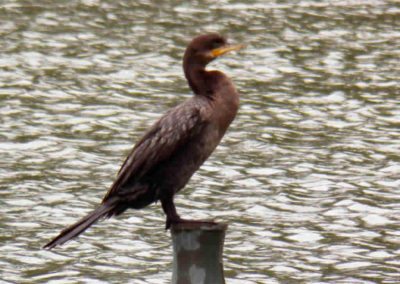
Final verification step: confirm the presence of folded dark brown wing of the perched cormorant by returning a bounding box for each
[103,104,205,202]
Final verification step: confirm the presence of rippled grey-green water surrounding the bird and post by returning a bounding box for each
[0,0,400,284]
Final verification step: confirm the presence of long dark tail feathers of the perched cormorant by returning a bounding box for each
[43,199,117,250]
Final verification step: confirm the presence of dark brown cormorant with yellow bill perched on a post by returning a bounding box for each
[43,33,244,249]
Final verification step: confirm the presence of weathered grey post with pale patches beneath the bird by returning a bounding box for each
[171,223,228,284]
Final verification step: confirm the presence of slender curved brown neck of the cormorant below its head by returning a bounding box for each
[184,65,213,98]
